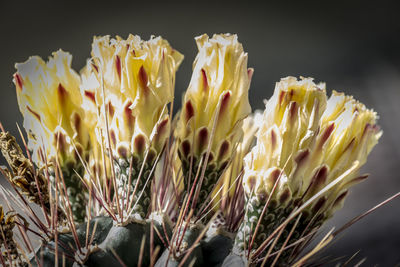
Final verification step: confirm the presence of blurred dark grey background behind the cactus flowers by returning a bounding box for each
[0,0,400,266]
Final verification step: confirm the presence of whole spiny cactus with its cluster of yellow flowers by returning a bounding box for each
[0,34,398,267]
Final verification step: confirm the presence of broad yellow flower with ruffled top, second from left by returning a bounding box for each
[81,35,183,161]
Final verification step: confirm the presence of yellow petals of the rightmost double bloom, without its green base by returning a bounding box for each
[243,77,382,216]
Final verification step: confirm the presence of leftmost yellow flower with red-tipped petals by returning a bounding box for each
[14,50,90,166]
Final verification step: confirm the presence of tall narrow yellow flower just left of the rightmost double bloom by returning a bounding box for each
[176,34,253,175]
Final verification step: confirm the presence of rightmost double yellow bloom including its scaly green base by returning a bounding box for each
[223,77,382,264]
